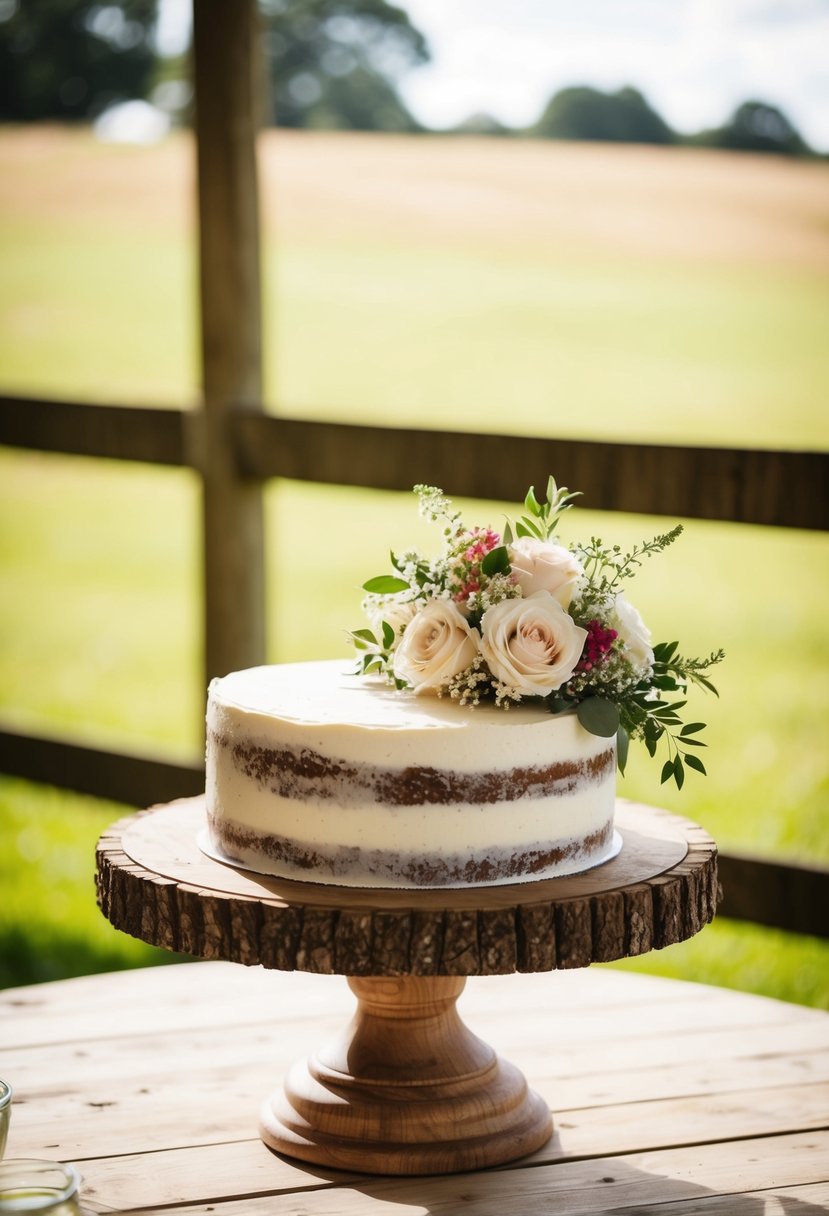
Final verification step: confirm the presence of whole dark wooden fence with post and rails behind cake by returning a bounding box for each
[0,0,829,938]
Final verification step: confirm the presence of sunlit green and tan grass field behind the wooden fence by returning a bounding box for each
[0,129,829,1007]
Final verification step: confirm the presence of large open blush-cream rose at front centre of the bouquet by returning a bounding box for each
[480,591,587,697]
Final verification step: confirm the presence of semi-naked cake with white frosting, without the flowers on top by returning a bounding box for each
[207,662,616,888]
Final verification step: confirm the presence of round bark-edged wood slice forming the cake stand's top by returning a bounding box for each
[96,798,718,976]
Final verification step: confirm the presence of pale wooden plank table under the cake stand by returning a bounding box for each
[0,962,829,1216]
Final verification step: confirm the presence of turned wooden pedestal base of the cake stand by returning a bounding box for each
[260,976,553,1173]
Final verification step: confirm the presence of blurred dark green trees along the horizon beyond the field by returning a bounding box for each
[0,0,812,156]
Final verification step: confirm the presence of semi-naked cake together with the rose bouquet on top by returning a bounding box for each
[200,478,722,889]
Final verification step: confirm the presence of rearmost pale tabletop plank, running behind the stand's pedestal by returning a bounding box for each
[0,962,811,1047]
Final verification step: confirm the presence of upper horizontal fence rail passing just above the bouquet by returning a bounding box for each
[0,396,829,530]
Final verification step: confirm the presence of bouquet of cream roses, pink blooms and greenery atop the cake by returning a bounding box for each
[350,477,723,787]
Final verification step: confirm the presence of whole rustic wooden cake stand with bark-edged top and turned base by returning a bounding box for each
[97,798,717,1173]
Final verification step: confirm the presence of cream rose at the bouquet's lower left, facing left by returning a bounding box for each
[394,599,478,692]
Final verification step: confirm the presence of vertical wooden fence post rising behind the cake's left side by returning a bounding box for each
[193,0,265,679]
